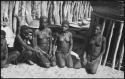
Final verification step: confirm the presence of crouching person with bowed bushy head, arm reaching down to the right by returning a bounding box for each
[14,15,40,65]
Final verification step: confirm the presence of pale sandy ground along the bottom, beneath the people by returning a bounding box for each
[1,64,124,78]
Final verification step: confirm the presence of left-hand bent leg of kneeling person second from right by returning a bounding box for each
[56,52,65,68]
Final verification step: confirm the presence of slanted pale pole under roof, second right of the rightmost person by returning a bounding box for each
[103,21,115,66]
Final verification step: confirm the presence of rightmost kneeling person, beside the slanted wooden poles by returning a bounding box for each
[83,25,106,74]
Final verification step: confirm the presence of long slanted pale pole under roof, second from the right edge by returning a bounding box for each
[112,22,124,69]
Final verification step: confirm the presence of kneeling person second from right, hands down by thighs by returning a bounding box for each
[56,21,73,68]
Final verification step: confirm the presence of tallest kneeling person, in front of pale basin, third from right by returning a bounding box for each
[35,16,56,67]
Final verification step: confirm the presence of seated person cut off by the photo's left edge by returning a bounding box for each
[1,30,20,68]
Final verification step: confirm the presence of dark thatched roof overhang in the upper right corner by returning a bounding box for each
[90,0,124,20]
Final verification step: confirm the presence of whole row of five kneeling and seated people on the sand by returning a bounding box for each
[1,15,106,74]
